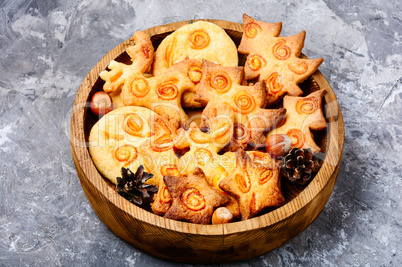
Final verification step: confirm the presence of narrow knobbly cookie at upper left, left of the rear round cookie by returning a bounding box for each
[99,31,154,108]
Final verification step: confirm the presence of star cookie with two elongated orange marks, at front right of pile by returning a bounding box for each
[219,149,285,220]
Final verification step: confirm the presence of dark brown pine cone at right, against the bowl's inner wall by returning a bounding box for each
[281,148,320,185]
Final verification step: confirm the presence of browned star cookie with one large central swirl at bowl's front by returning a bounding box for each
[163,168,230,224]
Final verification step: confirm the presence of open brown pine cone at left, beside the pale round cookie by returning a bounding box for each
[116,165,158,205]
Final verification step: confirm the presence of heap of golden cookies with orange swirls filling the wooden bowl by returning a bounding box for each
[89,15,327,224]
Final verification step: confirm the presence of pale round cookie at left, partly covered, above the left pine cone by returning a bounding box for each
[89,106,169,184]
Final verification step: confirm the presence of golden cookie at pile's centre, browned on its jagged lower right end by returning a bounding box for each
[197,61,285,151]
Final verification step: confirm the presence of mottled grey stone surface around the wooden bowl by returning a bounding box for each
[0,0,402,266]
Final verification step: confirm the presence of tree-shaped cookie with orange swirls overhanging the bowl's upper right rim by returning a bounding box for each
[238,14,323,106]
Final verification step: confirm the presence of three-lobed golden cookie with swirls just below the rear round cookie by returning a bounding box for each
[121,59,202,128]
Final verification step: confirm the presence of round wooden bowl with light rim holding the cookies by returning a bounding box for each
[70,20,344,263]
